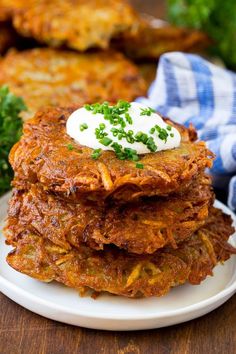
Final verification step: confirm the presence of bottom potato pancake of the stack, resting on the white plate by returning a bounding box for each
[7,208,236,297]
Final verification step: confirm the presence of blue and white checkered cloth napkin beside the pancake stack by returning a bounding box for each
[137,52,236,210]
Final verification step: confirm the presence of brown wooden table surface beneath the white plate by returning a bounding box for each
[0,0,236,354]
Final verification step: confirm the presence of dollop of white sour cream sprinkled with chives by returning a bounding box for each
[66,102,181,155]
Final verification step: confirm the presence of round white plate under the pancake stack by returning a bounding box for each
[0,198,236,331]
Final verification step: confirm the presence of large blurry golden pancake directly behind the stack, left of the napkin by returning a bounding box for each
[0,48,147,119]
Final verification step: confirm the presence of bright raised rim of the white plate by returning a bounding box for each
[0,200,236,321]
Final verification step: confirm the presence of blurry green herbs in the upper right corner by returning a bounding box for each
[168,0,236,70]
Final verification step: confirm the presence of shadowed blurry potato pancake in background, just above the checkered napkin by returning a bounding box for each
[113,16,210,60]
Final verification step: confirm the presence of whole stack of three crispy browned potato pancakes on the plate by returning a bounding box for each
[5,107,236,297]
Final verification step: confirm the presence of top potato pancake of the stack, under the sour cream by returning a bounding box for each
[10,108,212,202]
